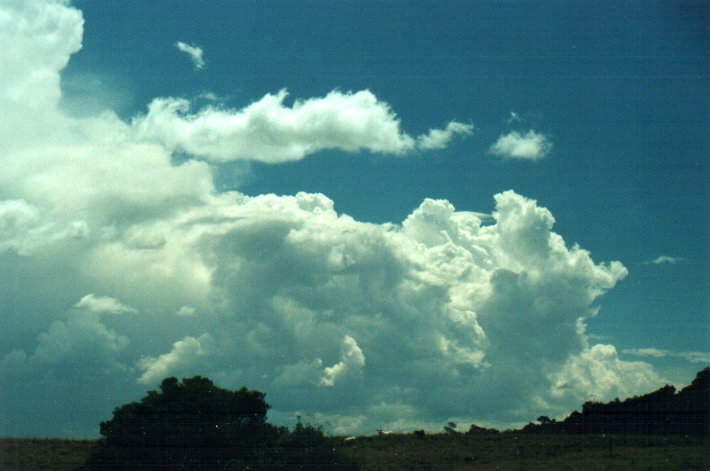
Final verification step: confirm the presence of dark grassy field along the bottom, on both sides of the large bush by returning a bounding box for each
[0,433,710,471]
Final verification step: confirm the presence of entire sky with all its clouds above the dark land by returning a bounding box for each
[0,0,710,438]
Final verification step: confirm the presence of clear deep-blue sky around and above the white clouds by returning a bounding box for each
[64,0,710,376]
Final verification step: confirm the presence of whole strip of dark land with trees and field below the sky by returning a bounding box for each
[0,368,710,470]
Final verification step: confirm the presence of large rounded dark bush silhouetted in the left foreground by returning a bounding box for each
[85,376,349,470]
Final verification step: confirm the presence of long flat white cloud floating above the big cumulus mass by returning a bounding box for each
[133,90,472,163]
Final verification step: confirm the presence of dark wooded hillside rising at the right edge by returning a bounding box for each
[523,367,710,436]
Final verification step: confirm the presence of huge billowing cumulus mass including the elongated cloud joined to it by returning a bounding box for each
[0,0,659,436]
